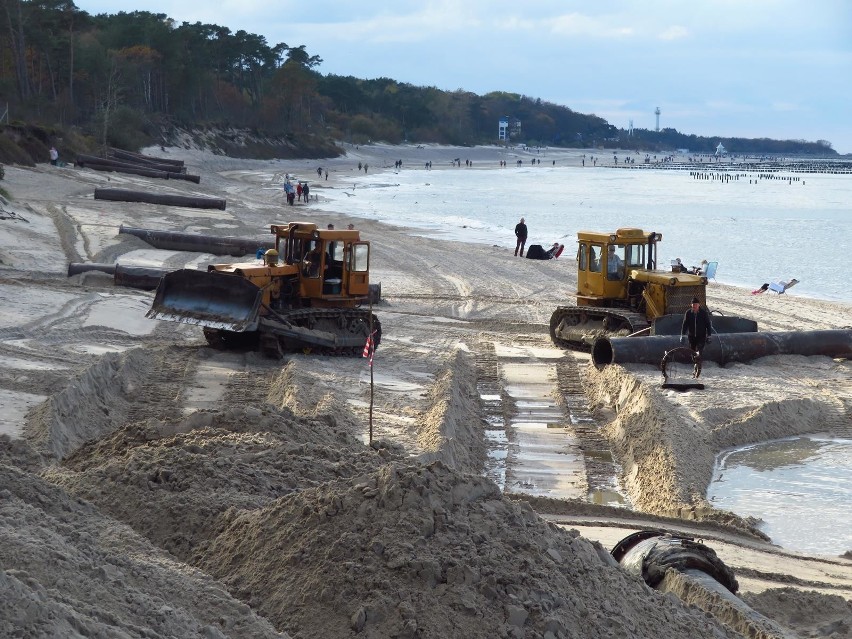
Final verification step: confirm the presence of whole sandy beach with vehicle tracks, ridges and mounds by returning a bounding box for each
[0,145,852,639]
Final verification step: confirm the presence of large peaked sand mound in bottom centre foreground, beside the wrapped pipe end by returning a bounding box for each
[198,462,725,639]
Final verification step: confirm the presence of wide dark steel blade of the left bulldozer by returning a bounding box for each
[146,269,263,333]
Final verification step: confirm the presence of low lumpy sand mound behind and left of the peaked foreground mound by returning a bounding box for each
[44,408,390,558]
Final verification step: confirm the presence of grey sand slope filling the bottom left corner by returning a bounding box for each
[0,465,282,639]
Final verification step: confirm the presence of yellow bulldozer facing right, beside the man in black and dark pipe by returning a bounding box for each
[550,228,757,350]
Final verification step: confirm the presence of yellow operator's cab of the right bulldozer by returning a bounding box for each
[577,229,662,306]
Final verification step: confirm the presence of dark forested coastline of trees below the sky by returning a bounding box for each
[0,0,834,155]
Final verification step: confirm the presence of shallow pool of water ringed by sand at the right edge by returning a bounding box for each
[707,437,852,555]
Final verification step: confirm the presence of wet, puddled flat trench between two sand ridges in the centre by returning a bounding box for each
[477,344,626,506]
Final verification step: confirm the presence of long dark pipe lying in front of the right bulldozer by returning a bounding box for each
[592,329,852,366]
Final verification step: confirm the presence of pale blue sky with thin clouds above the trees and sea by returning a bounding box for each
[75,0,852,153]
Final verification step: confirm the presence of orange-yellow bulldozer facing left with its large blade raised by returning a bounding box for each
[147,222,382,357]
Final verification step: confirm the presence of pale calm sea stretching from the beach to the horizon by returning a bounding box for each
[324,165,852,302]
